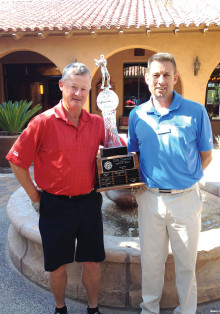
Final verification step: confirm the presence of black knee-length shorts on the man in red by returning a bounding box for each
[39,191,105,271]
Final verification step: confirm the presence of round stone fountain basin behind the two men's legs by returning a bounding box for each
[7,188,220,308]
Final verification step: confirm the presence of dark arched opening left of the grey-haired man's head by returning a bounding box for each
[0,51,61,111]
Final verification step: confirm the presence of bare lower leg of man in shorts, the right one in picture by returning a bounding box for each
[82,262,100,308]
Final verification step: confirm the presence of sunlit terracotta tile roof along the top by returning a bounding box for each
[0,0,220,32]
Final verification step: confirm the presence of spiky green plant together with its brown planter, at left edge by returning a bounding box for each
[0,100,42,167]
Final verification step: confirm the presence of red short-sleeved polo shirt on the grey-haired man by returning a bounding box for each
[6,101,105,196]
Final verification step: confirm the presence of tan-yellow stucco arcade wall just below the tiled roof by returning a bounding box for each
[0,30,220,115]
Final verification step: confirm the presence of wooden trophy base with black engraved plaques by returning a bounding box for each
[96,153,145,192]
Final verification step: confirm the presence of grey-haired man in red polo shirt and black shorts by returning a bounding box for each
[6,63,105,314]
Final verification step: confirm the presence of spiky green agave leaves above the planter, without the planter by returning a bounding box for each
[0,100,42,135]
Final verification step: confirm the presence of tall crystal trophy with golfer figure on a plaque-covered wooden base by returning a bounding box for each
[95,55,144,192]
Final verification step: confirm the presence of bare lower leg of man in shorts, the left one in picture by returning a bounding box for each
[50,265,67,308]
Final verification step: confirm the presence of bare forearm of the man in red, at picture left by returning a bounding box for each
[10,162,41,203]
